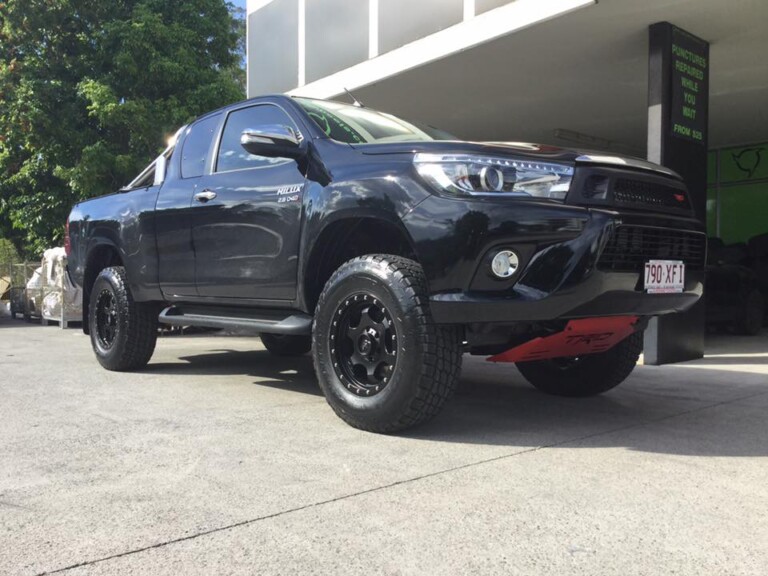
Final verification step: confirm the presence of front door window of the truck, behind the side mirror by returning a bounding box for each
[216,104,296,172]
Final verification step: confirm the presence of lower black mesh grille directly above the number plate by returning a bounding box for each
[597,225,707,272]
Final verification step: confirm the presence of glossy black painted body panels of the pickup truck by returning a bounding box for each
[69,96,703,340]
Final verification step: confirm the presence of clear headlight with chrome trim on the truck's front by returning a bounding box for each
[413,153,573,200]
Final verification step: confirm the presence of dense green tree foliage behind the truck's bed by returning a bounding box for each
[0,0,244,254]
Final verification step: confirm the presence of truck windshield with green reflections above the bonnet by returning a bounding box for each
[296,98,456,144]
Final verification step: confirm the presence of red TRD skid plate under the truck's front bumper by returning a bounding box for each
[487,316,638,362]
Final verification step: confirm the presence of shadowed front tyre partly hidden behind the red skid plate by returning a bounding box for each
[516,332,643,397]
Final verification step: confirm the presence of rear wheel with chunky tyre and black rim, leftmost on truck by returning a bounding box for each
[88,266,158,371]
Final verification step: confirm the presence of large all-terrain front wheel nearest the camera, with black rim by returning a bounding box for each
[312,254,461,433]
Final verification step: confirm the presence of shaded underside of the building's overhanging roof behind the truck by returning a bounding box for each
[295,0,768,156]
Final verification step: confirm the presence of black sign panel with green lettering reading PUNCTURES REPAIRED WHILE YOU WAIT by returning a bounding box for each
[671,26,709,144]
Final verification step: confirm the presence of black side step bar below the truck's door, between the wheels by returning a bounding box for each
[159,306,312,335]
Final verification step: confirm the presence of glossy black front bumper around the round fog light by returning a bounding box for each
[406,197,705,324]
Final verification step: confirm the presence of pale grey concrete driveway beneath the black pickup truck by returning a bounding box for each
[0,318,768,576]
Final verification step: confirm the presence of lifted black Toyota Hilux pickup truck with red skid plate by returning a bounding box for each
[66,96,706,432]
